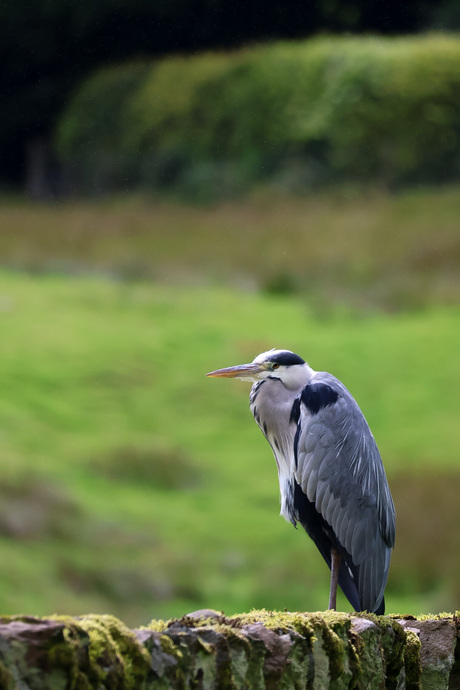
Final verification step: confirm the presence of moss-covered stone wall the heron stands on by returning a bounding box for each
[0,610,460,690]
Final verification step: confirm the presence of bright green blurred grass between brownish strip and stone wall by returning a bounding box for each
[0,268,460,624]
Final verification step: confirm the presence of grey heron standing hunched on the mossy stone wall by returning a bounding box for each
[207,349,395,614]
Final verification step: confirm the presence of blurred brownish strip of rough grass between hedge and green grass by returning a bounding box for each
[0,186,460,316]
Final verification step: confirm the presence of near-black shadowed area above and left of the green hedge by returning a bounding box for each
[0,0,460,184]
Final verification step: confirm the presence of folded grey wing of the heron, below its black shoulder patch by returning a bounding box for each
[295,375,395,611]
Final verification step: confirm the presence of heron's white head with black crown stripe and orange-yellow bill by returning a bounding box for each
[206,349,311,388]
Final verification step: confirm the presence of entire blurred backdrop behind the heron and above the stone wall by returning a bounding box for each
[0,0,460,625]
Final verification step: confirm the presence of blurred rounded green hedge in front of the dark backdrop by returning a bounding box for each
[56,35,460,196]
